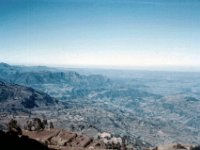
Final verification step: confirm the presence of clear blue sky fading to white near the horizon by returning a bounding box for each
[0,0,200,67]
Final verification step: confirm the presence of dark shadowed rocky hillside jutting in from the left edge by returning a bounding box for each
[0,81,58,114]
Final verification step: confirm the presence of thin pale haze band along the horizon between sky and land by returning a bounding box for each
[1,62,200,72]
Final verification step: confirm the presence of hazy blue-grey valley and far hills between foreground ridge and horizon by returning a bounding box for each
[0,63,200,145]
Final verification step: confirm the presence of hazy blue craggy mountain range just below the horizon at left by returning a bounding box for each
[0,63,109,88]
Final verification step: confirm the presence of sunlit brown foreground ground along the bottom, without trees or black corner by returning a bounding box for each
[23,129,200,150]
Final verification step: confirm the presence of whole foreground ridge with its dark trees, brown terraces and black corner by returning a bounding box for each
[0,118,200,150]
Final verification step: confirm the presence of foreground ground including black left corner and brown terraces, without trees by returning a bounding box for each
[0,129,200,150]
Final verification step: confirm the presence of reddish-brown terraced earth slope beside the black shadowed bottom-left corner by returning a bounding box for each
[23,129,105,150]
